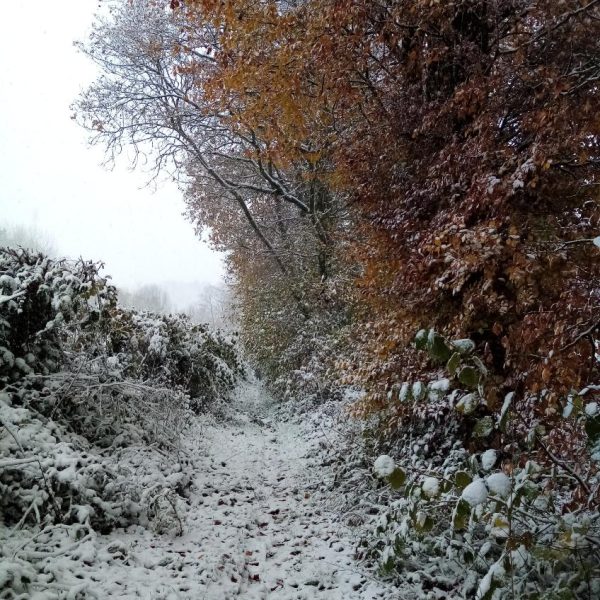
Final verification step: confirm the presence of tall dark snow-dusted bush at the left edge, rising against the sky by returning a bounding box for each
[0,248,116,383]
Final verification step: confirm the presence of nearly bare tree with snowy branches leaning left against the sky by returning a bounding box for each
[75,0,348,390]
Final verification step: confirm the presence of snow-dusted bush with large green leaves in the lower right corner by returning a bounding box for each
[347,331,600,600]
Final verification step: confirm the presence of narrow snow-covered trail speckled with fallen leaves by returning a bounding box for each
[90,384,396,600]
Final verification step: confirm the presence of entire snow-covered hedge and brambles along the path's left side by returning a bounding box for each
[0,249,242,598]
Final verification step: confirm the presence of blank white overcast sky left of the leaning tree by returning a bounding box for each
[0,0,223,296]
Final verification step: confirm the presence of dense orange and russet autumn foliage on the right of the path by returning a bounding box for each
[173,0,600,432]
